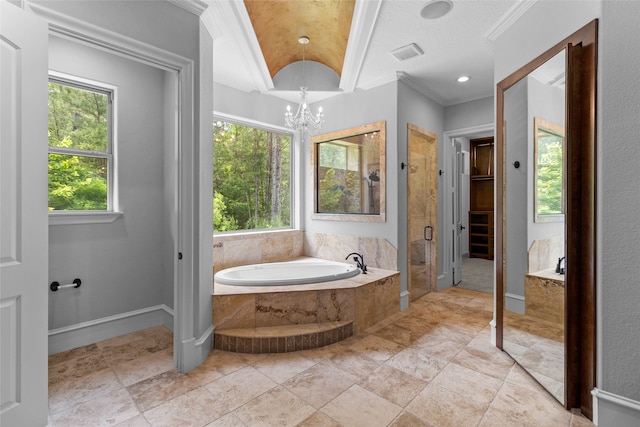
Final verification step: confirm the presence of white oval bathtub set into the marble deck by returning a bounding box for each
[213,258,360,286]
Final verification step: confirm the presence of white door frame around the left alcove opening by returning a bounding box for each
[28,3,213,372]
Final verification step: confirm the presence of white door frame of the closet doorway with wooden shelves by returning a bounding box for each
[438,123,495,290]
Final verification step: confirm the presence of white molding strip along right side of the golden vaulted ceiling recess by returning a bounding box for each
[340,0,382,92]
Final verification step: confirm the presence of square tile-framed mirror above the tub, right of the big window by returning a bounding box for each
[311,122,386,222]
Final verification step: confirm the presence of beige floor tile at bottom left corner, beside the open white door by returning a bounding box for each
[52,388,140,427]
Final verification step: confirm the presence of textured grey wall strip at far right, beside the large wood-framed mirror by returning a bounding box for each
[597,1,640,410]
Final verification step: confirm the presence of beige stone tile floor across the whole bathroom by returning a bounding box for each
[49,289,593,427]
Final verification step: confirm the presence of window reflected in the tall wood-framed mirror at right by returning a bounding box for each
[533,117,565,222]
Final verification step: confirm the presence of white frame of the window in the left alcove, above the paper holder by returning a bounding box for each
[47,70,122,225]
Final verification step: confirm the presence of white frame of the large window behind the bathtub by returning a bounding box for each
[211,111,304,236]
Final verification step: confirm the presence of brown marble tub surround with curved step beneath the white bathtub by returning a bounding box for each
[213,268,400,353]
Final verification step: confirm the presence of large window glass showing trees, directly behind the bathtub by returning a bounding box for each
[213,121,291,232]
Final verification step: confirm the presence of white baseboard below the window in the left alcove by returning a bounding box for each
[49,304,173,354]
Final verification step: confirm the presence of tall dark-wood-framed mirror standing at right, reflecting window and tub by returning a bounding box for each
[495,20,597,418]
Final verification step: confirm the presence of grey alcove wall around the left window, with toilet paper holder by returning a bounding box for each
[49,37,171,329]
